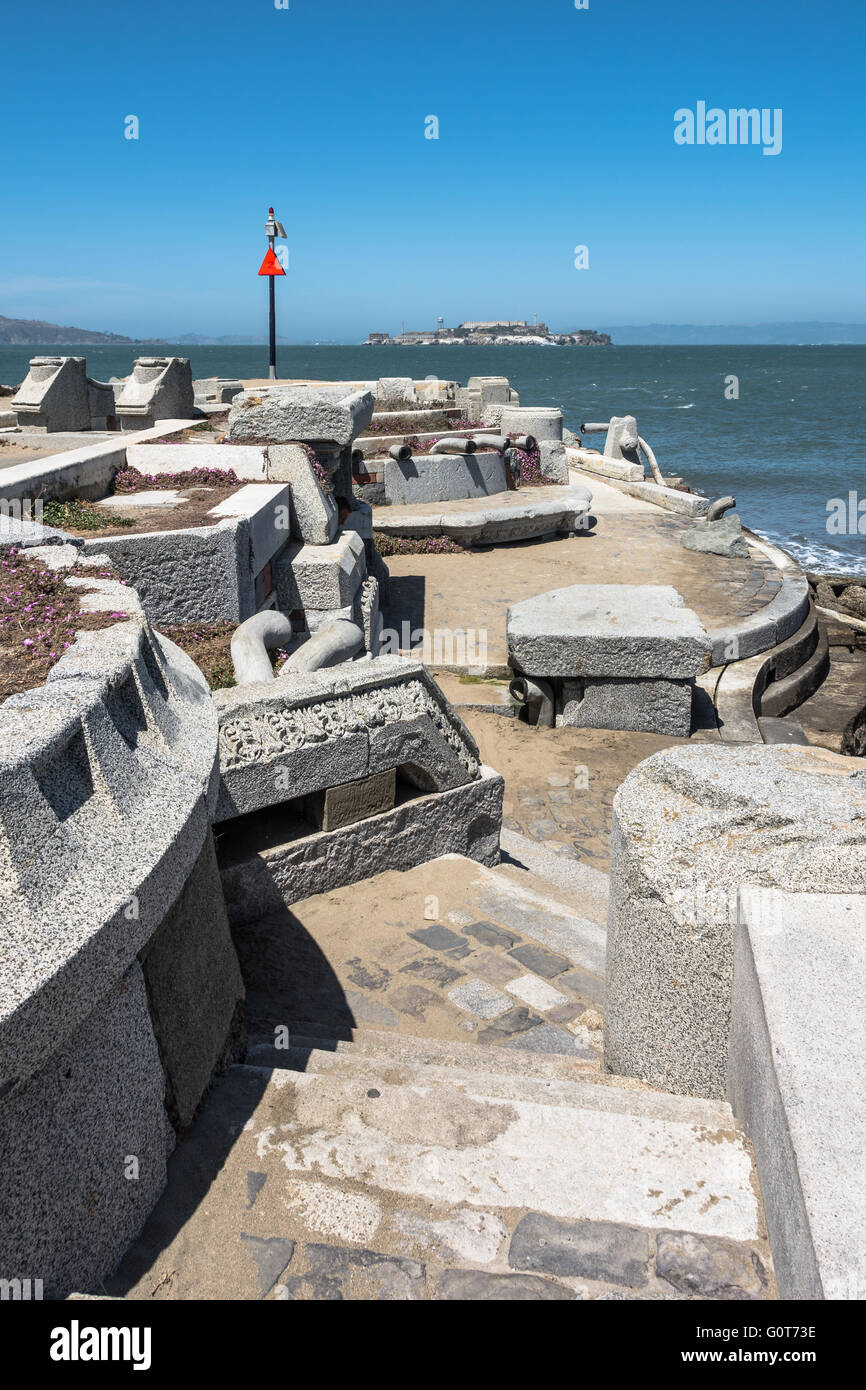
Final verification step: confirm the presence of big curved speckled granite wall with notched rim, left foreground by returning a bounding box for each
[0,546,243,1295]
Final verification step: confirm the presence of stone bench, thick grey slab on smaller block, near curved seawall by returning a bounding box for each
[506,584,710,737]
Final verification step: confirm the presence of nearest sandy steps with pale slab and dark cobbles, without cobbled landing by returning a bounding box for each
[107,1055,773,1300]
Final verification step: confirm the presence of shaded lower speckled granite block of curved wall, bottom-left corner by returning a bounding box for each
[0,962,174,1298]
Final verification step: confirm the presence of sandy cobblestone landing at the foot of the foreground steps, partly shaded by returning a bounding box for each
[235,860,605,1063]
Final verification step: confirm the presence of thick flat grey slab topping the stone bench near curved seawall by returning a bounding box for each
[507,584,710,680]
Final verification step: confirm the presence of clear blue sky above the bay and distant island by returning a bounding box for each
[0,0,866,341]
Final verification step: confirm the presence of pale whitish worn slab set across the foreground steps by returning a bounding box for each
[229,1062,758,1240]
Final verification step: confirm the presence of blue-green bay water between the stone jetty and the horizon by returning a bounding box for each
[0,345,866,574]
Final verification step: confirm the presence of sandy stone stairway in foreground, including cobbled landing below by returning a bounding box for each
[107,835,774,1300]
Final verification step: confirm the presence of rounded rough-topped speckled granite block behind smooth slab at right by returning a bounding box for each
[605,744,866,1097]
